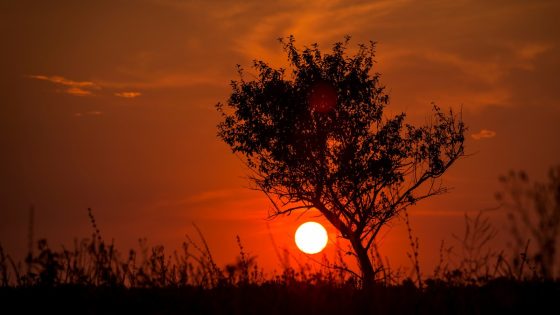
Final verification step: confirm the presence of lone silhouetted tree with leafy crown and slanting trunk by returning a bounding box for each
[216,36,465,285]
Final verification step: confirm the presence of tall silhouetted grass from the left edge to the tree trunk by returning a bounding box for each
[0,209,358,288]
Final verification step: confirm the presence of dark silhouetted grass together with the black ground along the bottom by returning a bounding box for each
[0,210,560,314]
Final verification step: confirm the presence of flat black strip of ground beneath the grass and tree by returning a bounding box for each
[0,281,560,315]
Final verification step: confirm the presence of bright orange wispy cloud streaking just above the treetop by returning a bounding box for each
[231,0,410,63]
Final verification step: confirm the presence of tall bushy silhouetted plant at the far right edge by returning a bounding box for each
[496,166,560,279]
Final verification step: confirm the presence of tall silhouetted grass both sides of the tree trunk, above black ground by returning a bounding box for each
[0,209,556,289]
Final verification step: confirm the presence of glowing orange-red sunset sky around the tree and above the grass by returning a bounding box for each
[0,0,560,273]
